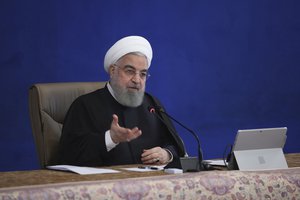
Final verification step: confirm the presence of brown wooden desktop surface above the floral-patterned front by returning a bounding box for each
[0,153,300,188]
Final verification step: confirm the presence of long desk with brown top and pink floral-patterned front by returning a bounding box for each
[0,154,300,199]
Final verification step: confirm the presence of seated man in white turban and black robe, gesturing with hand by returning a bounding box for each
[60,36,185,166]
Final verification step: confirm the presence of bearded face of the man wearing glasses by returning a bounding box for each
[109,54,148,107]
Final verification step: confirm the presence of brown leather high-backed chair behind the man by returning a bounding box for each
[29,82,106,168]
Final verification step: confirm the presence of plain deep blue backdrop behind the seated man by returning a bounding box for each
[0,0,300,171]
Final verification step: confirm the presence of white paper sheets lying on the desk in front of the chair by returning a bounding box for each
[47,165,119,175]
